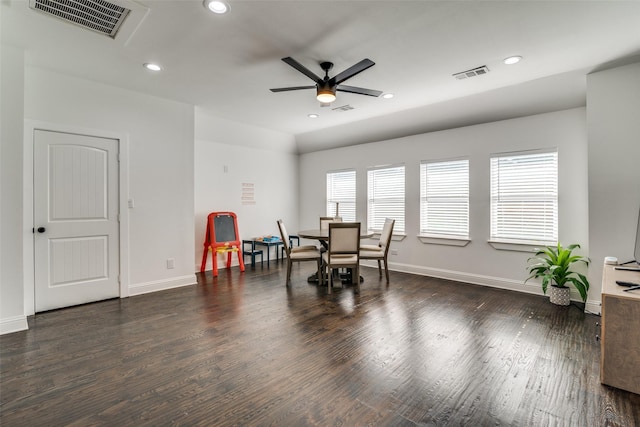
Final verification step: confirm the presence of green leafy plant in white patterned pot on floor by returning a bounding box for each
[525,243,589,305]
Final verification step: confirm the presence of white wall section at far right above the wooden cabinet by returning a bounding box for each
[587,63,640,310]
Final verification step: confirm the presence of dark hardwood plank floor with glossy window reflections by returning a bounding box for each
[0,262,640,427]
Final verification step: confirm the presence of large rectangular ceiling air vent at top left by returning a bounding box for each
[29,0,130,38]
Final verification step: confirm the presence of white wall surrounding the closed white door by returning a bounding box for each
[25,67,195,300]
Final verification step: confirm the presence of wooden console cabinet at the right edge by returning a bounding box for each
[600,264,640,394]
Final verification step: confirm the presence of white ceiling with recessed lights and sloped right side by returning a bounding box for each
[0,0,640,152]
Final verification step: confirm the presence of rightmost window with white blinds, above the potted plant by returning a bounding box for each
[491,151,558,242]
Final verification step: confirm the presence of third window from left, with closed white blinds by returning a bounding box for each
[420,159,469,238]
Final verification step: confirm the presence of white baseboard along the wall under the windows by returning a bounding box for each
[362,261,600,314]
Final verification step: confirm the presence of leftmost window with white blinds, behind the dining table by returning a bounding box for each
[327,170,356,222]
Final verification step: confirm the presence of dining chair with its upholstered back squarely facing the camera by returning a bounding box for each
[323,222,360,293]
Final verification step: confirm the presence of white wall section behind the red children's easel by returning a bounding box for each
[194,109,298,271]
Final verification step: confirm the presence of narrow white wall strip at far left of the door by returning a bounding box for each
[0,45,27,334]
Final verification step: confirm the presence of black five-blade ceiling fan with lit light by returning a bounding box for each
[270,56,382,105]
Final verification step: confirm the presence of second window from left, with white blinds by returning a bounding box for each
[367,165,404,234]
